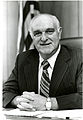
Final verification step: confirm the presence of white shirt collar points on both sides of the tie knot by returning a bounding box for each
[39,44,61,69]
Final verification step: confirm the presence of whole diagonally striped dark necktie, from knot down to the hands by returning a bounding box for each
[40,61,50,97]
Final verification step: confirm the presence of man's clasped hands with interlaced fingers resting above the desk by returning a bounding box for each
[14,92,46,111]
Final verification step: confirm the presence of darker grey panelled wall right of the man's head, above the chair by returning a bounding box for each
[40,1,82,38]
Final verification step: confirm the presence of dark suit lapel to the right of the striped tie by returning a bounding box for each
[50,47,70,96]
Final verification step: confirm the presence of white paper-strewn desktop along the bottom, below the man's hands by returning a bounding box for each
[3,109,83,120]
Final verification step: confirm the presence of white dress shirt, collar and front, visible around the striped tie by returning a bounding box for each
[38,45,61,94]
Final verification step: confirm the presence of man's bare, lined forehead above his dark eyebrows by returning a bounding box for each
[32,16,54,31]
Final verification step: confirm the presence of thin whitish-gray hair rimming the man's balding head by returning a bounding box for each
[29,14,60,38]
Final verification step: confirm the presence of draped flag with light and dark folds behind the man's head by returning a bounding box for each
[17,1,39,53]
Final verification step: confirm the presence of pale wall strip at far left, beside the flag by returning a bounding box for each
[3,2,18,81]
